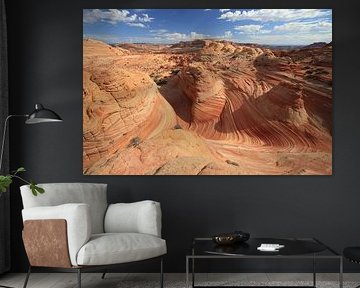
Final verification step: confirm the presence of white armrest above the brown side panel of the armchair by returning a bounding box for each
[22,203,91,266]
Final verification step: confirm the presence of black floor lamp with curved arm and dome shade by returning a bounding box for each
[0,104,63,288]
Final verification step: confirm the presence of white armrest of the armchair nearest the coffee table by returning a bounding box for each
[104,200,161,237]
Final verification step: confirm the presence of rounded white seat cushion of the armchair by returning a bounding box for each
[77,233,166,265]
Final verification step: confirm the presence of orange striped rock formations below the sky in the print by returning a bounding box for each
[83,39,332,175]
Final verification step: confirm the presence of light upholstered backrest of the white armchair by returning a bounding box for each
[20,183,107,234]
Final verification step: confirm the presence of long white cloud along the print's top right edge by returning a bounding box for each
[218,9,332,22]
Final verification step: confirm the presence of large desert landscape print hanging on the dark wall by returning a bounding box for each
[83,9,332,175]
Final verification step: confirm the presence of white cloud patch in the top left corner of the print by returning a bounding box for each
[83,9,154,27]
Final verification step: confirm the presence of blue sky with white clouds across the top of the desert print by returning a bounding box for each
[83,9,332,45]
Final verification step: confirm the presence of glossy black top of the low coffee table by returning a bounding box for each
[192,238,339,257]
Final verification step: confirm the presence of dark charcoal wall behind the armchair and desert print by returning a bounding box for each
[7,0,360,272]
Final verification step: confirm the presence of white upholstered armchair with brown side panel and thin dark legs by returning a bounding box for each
[20,183,167,288]
